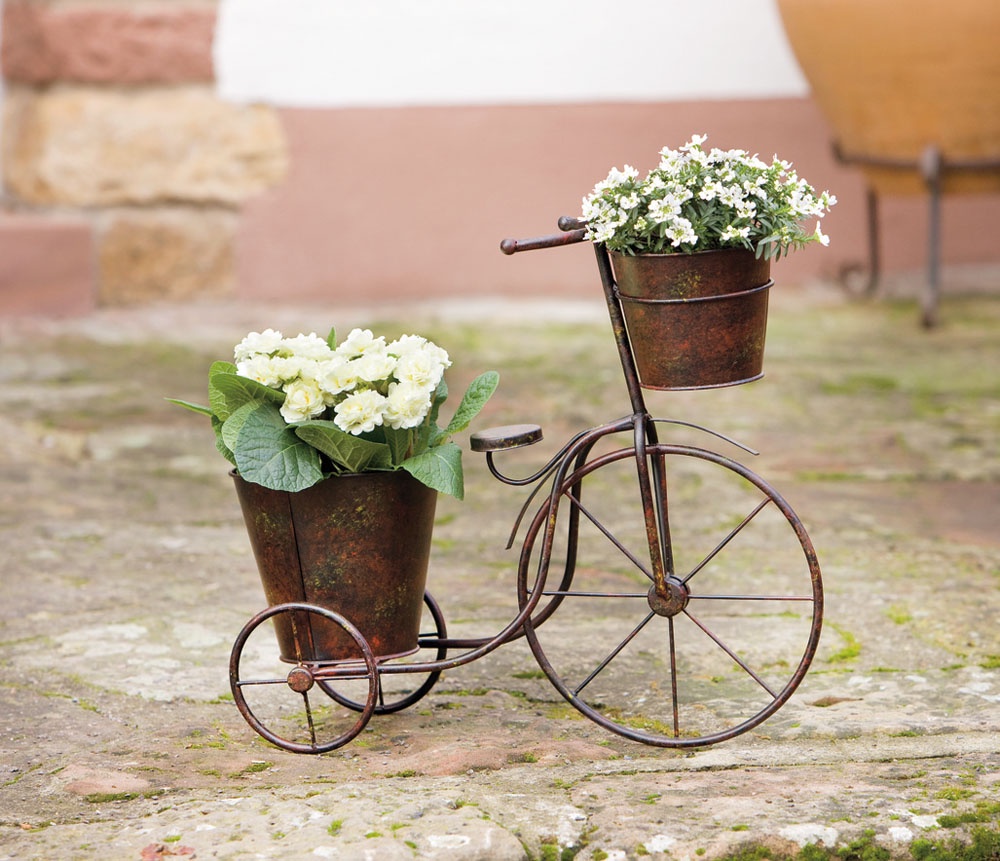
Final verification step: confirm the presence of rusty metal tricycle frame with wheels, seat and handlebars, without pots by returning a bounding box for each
[230,218,823,753]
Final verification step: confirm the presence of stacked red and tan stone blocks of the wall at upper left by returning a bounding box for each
[0,0,288,311]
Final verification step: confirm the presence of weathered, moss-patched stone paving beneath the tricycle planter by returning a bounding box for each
[0,280,1000,861]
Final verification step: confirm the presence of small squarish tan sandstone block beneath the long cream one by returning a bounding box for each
[98,208,237,306]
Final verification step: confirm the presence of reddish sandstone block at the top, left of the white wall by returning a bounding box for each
[2,0,216,84]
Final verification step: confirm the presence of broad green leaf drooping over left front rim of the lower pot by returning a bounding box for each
[234,403,323,493]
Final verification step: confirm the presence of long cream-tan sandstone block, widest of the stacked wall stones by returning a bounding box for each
[3,86,288,206]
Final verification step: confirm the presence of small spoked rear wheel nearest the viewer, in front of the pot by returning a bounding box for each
[229,604,379,753]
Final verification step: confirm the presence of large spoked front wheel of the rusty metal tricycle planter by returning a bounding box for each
[518,444,823,747]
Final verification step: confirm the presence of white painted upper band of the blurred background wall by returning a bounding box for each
[215,0,808,107]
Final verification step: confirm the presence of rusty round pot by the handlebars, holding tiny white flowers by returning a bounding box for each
[611,248,772,389]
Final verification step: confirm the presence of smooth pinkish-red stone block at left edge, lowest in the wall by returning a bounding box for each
[0,214,96,317]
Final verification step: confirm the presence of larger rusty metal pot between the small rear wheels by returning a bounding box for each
[232,470,437,663]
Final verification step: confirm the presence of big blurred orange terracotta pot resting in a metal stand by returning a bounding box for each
[778,0,1000,194]
